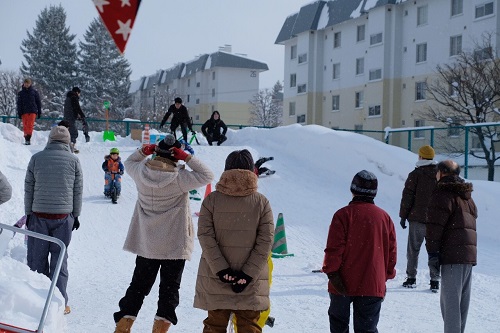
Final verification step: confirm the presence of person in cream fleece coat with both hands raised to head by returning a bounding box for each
[113,134,214,333]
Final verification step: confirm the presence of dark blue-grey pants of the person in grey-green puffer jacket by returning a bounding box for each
[27,213,74,305]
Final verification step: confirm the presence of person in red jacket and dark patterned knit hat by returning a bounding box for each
[322,170,397,333]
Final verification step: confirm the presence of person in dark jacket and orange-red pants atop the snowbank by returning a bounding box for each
[17,79,42,145]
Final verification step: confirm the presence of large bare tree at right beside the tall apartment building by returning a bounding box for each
[425,33,500,181]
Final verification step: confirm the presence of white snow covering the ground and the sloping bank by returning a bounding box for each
[0,123,500,333]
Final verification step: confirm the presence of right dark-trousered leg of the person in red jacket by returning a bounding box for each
[353,296,383,333]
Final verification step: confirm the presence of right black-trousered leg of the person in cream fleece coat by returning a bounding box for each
[156,259,186,325]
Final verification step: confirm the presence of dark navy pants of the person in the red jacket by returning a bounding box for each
[328,294,383,333]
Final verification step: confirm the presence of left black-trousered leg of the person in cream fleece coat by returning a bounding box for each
[113,256,160,323]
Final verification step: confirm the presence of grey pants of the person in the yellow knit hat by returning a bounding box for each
[406,221,440,281]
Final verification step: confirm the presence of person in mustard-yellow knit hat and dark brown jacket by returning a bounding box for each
[399,145,440,292]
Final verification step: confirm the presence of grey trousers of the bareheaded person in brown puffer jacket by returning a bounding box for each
[441,264,472,333]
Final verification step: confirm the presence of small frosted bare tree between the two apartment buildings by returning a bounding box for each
[250,81,283,127]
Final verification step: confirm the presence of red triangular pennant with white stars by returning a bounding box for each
[92,0,141,54]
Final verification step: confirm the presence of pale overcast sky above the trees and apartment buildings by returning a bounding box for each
[0,0,311,89]
